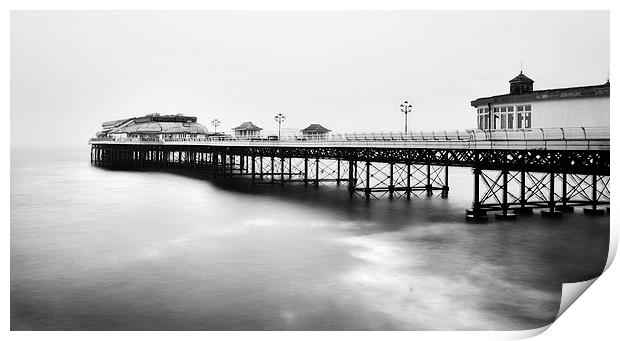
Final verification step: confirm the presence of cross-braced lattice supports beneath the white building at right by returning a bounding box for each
[479,170,610,210]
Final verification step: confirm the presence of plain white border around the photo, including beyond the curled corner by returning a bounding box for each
[1,0,620,340]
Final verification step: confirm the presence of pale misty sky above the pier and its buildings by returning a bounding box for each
[11,11,610,145]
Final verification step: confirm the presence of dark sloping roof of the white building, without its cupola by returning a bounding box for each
[471,82,609,107]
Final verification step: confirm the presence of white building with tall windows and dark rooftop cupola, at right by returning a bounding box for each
[471,73,609,129]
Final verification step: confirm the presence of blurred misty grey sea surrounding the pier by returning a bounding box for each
[11,147,609,330]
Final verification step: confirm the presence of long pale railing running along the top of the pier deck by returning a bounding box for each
[91,127,609,150]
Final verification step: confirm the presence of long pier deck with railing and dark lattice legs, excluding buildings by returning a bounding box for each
[90,127,610,222]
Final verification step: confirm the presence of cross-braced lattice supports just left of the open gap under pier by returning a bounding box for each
[353,162,447,199]
